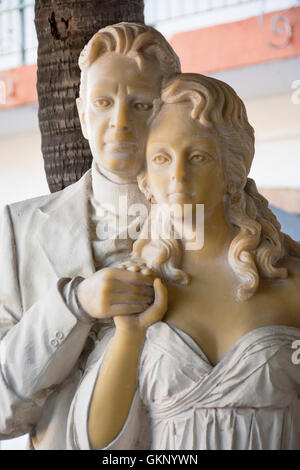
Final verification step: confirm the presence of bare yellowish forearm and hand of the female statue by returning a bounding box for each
[88,279,167,449]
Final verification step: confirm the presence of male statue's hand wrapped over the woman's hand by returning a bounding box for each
[77,268,154,318]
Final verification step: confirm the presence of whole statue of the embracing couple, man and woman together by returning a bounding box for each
[0,23,300,450]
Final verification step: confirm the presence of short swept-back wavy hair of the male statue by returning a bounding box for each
[78,22,181,101]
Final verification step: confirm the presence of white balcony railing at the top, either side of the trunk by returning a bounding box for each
[0,0,300,70]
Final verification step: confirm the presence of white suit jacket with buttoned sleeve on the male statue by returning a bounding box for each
[0,171,95,449]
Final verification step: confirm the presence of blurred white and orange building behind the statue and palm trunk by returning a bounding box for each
[0,0,300,449]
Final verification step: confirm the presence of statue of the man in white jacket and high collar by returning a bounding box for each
[0,23,180,450]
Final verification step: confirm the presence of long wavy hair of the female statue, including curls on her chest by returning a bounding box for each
[133,74,300,300]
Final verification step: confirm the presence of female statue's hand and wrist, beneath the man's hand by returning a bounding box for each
[114,278,168,335]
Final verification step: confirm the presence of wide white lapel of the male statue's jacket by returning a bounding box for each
[38,170,95,278]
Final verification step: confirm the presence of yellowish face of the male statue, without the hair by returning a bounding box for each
[77,53,161,183]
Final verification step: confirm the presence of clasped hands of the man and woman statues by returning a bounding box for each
[77,263,168,334]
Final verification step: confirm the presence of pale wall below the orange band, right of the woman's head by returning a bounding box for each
[207,57,300,188]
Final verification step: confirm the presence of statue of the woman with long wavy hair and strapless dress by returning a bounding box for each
[68,74,300,450]
